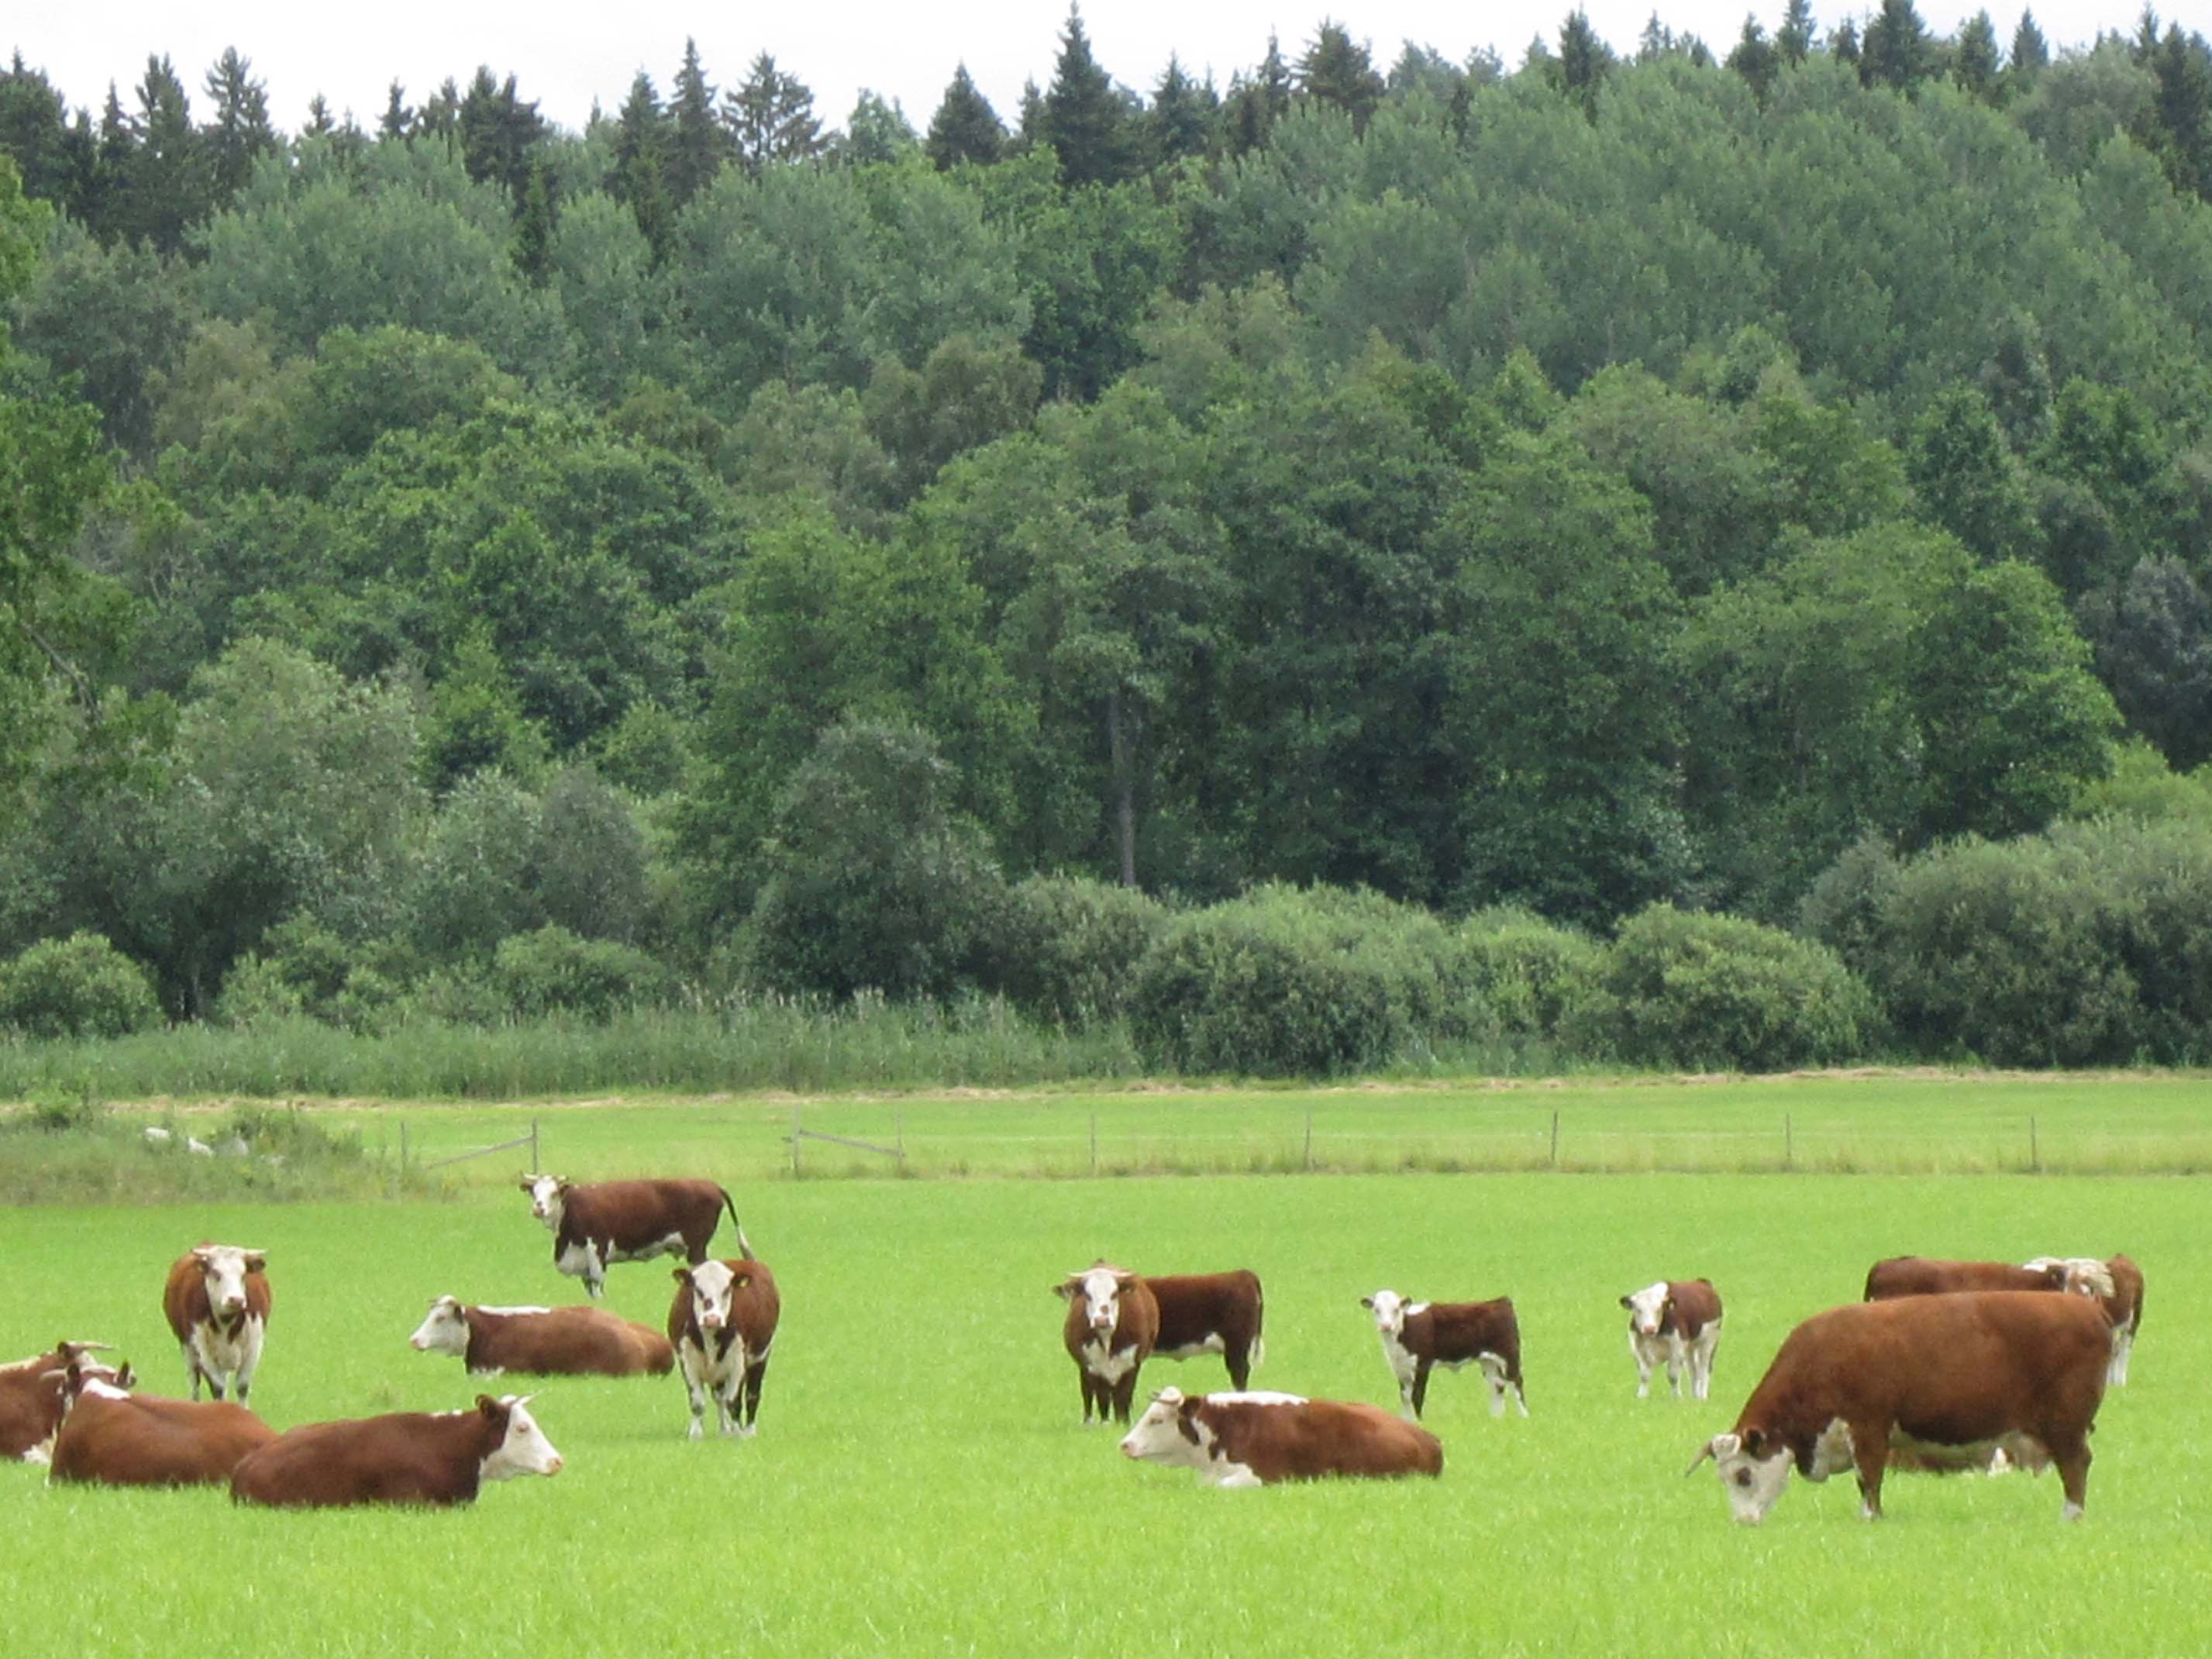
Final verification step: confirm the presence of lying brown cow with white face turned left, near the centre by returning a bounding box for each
[1122,1389,1445,1486]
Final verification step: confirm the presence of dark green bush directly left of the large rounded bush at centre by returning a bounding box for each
[980,876,1168,1029]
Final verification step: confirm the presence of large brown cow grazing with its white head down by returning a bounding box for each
[1690,1289,2113,1526]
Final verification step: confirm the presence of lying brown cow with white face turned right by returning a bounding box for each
[230,1394,562,1509]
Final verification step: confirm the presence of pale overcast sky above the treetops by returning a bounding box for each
[0,0,2141,130]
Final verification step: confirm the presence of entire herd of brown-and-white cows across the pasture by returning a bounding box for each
[0,1174,2144,1522]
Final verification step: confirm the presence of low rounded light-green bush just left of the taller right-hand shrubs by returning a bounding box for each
[1562,905,1873,1071]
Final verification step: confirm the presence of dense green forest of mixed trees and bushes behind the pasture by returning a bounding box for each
[0,0,2212,1071]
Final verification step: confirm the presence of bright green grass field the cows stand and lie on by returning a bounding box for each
[0,1095,2212,1654]
